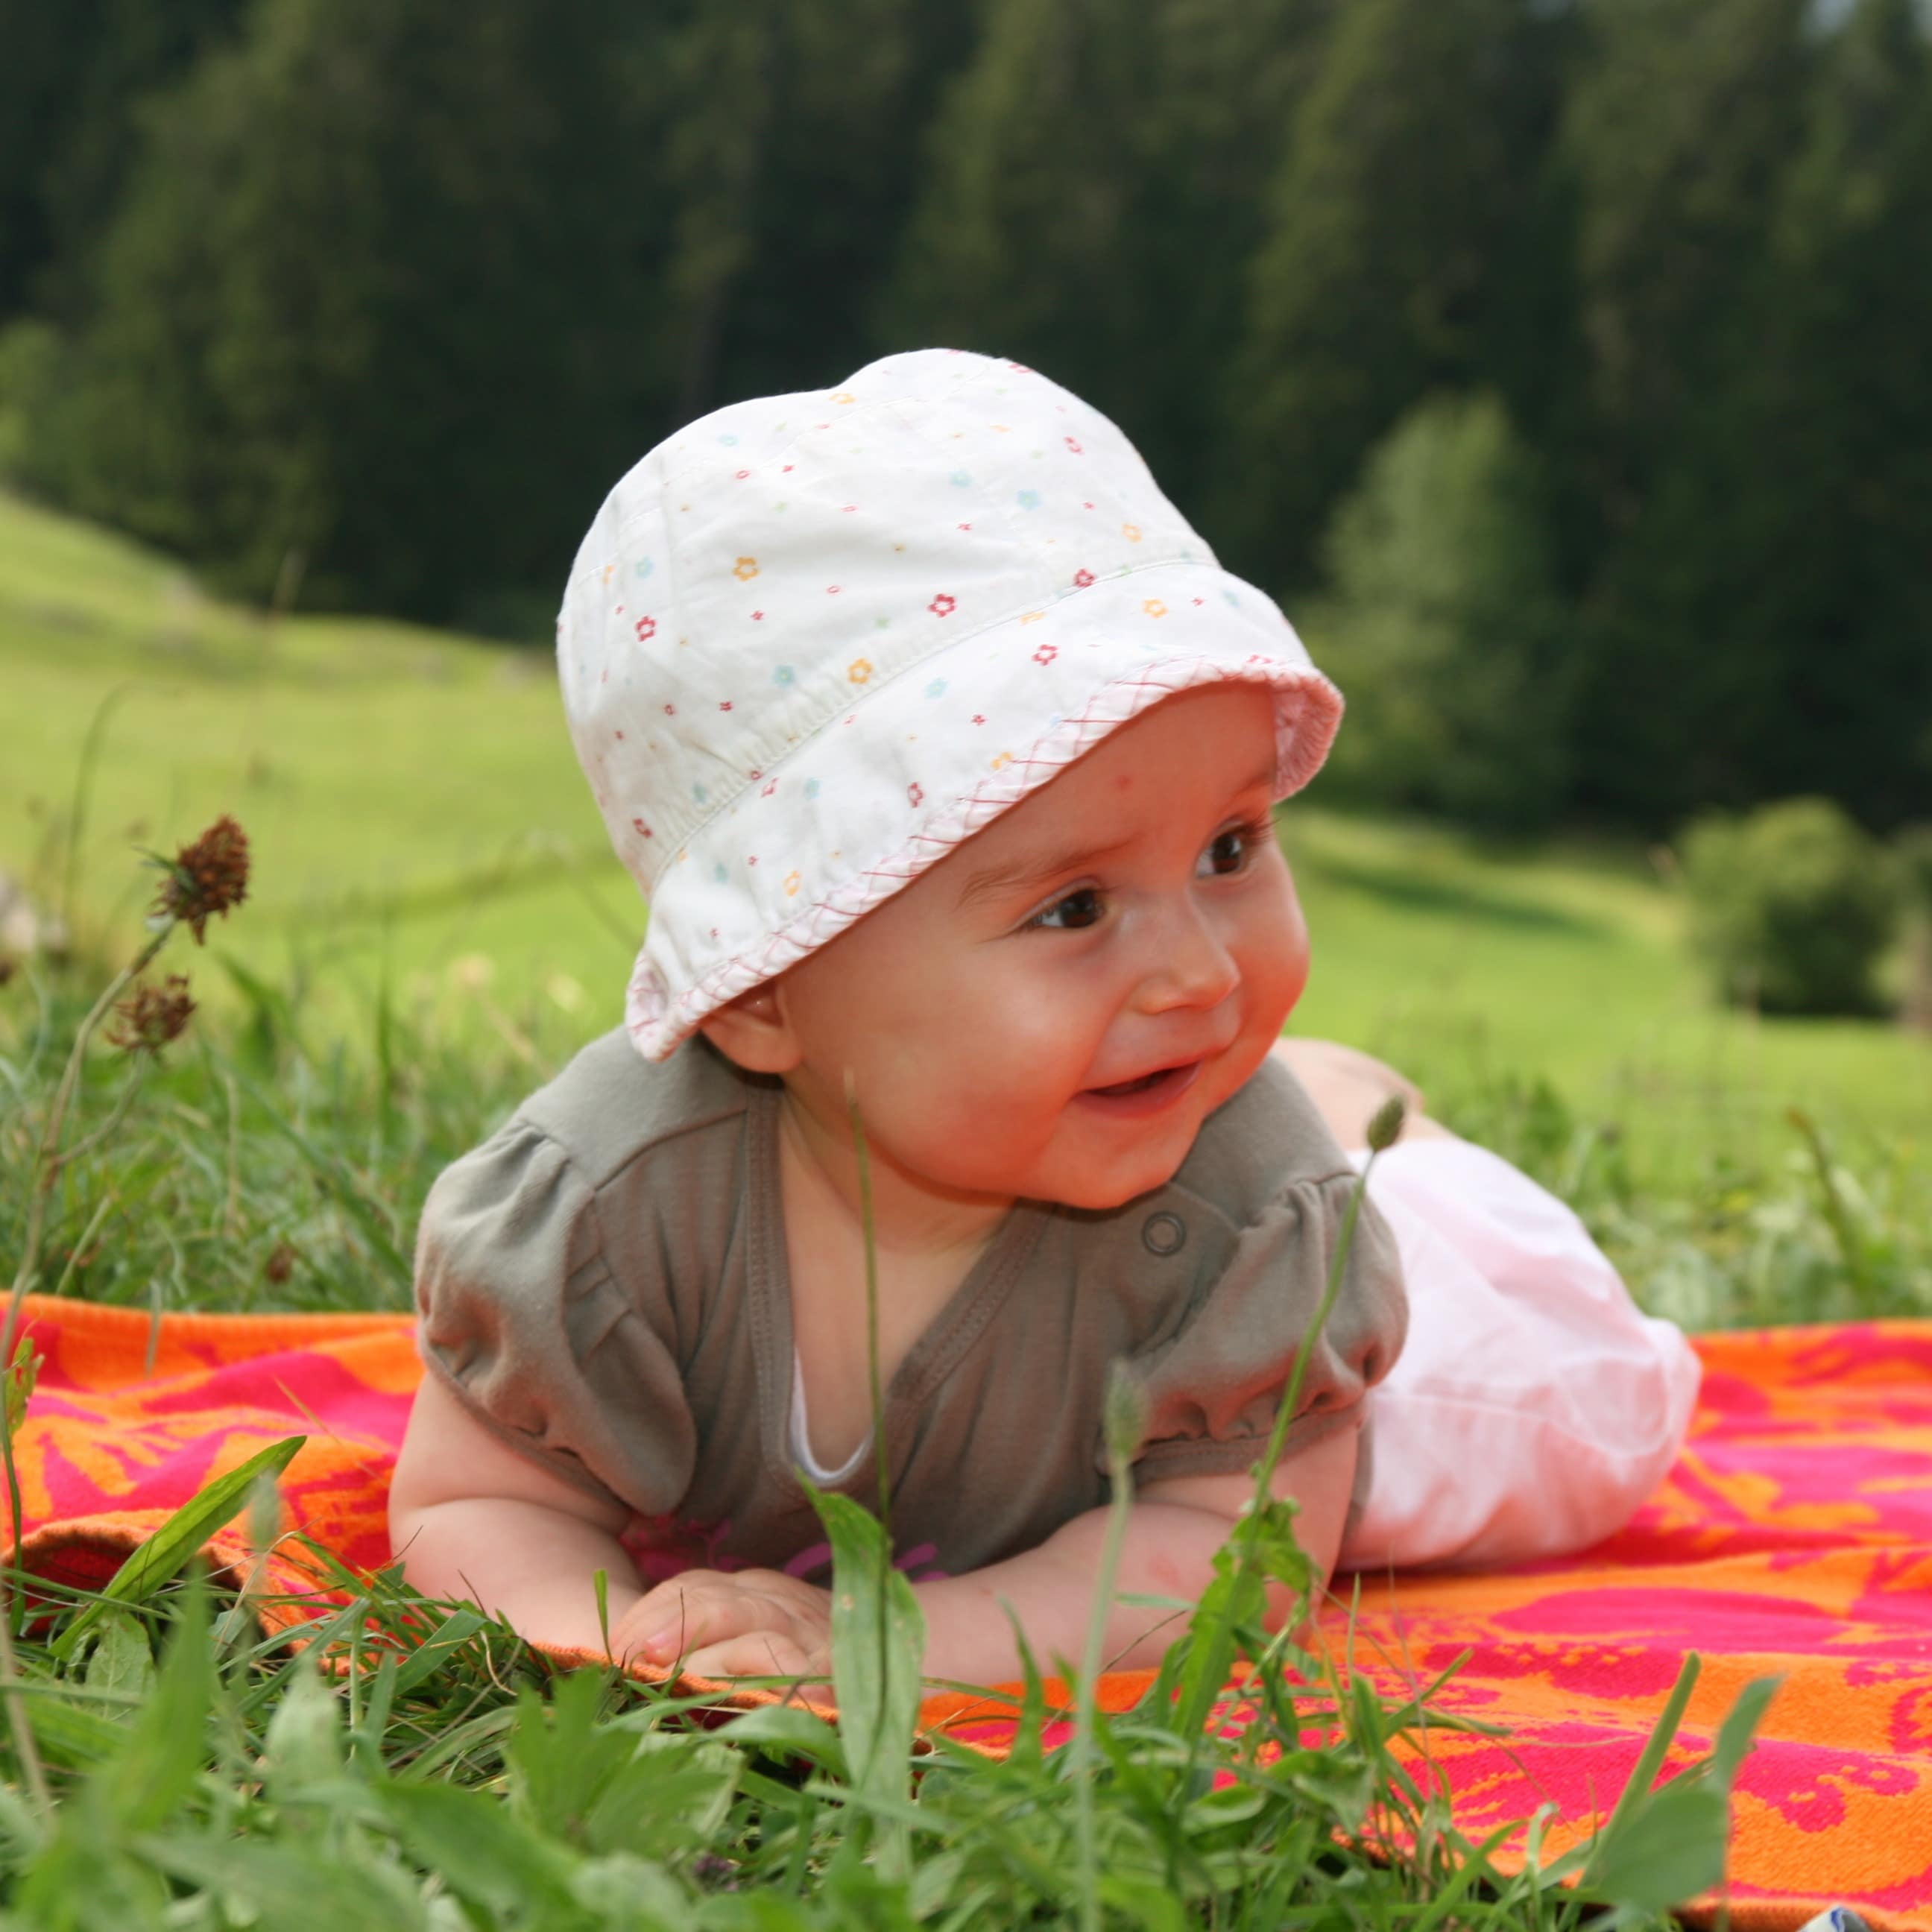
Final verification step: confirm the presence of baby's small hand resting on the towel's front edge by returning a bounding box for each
[610,1570,833,1677]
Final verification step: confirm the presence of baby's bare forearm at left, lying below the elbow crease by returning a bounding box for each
[396,1495,643,1655]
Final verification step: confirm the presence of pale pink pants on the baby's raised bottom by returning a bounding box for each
[1341,1140,1700,1570]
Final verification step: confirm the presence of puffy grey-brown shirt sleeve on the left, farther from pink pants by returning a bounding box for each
[415,1119,695,1515]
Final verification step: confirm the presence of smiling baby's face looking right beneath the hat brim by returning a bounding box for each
[768,684,1308,1208]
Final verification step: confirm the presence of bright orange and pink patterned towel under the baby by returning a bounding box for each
[4,1298,1932,1932]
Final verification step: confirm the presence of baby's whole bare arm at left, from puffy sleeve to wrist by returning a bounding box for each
[388,1376,643,1654]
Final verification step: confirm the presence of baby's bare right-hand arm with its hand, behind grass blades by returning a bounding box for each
[618,1430,1357,1683]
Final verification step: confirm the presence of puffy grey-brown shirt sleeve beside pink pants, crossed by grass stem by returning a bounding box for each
[1134,1171,1409,1482]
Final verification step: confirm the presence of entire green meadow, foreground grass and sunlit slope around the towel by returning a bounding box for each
[0,499,1932,1932]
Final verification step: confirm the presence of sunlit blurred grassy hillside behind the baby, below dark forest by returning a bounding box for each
[0,481,1932,1163]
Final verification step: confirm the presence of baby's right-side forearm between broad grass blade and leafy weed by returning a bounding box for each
[918,1503,1259,1683]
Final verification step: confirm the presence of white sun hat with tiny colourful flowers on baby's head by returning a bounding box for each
[556,350,1341,1061]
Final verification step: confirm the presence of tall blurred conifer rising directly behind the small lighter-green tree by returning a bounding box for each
[1213,0,1561,590]
